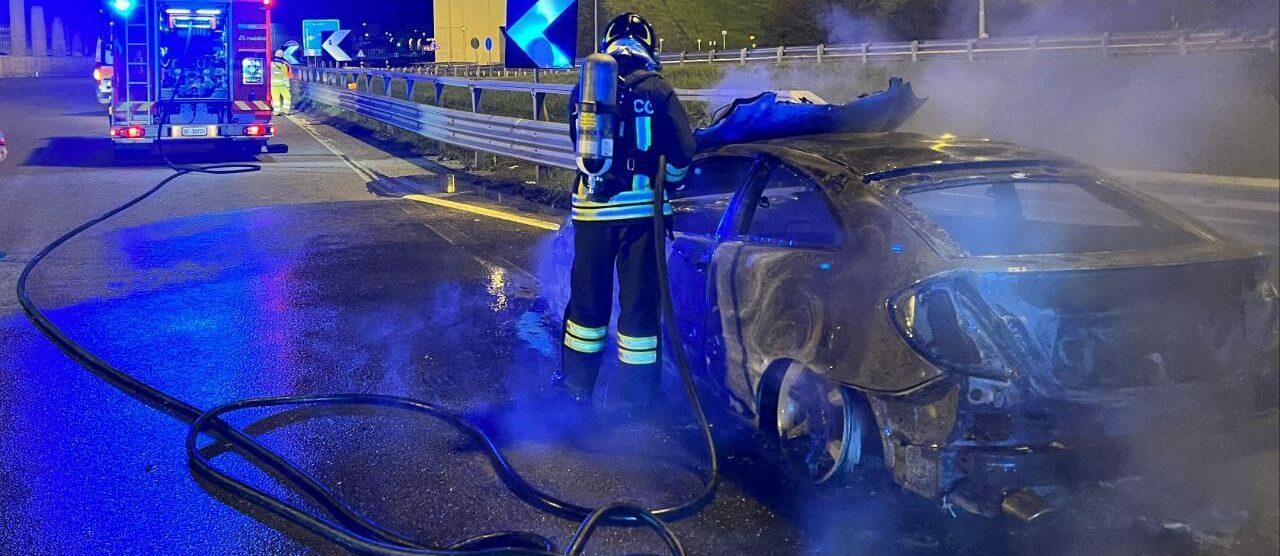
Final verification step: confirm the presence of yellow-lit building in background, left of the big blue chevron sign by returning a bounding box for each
[434,0,507,64]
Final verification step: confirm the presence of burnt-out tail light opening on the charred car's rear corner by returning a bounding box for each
[890,281,1012,379]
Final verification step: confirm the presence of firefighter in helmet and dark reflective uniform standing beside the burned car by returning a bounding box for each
[554,13,695,411]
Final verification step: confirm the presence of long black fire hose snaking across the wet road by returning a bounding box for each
[17,141,719,556]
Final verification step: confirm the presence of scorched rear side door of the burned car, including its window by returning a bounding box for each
[708,163,844,416]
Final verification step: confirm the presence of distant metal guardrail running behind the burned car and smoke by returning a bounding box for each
[662,28,1280,64]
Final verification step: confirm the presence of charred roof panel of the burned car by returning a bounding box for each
[748,132,1083,177]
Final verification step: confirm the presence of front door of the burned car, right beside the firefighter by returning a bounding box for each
[668,155,758,377]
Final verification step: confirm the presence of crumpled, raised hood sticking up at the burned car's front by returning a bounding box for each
[694,77,924,151]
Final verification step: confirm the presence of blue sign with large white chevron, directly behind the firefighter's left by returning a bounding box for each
[506,0,577,69]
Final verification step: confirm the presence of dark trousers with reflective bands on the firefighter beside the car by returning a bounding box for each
[557,218,662,405]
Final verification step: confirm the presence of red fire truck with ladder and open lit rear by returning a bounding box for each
[99,0,283,155]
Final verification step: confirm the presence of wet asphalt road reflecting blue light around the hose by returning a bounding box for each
[0,79,1280,555]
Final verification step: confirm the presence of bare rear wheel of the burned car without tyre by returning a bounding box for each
[774,364,867,484]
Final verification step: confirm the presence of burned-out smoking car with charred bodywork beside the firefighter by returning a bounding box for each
[669,133,1276,519]
